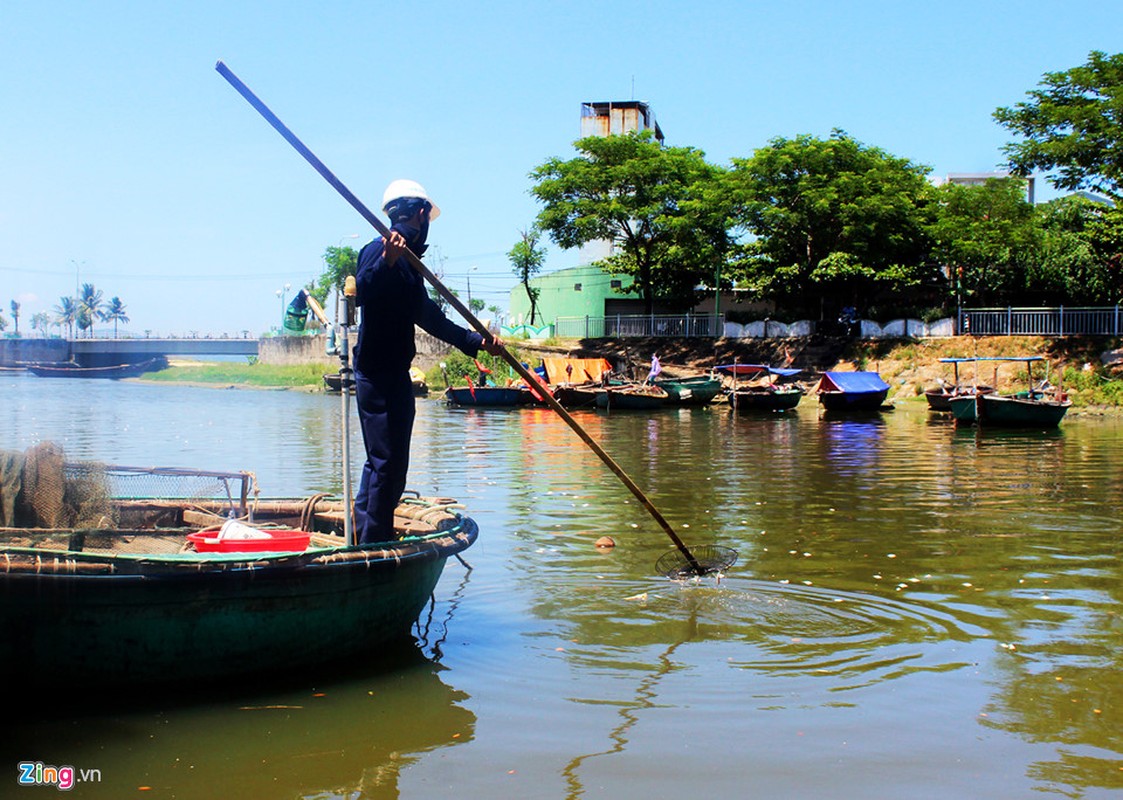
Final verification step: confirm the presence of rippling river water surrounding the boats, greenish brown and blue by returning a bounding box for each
[0,373,1123,800]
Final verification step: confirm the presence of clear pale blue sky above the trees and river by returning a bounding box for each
[0,0,1123,335]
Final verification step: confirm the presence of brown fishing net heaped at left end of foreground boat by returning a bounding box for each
[0,442,116,528]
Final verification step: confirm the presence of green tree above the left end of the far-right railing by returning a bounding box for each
[928,178,1040,304]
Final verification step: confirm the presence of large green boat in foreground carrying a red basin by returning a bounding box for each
[0,462,478,688]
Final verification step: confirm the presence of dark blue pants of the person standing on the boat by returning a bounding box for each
[355,370,416,545]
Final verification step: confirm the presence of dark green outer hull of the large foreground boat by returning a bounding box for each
[0,518,478,687]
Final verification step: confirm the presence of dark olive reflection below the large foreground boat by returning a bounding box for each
[3,647,476,798]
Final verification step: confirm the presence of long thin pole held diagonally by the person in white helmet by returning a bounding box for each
[214,61,704,575]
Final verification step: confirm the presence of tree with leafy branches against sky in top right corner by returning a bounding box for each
[994,51,1123,203]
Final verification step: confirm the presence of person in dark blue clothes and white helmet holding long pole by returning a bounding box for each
[354,180,503,545]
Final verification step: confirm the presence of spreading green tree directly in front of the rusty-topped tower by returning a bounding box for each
[530,130,725,312]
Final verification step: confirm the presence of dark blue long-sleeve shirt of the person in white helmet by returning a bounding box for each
[355,226,483,375]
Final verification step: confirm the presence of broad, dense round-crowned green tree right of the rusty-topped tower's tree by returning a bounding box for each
[728,130,934,315]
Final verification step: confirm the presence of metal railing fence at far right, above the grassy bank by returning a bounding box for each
[958,306,1120,336]
